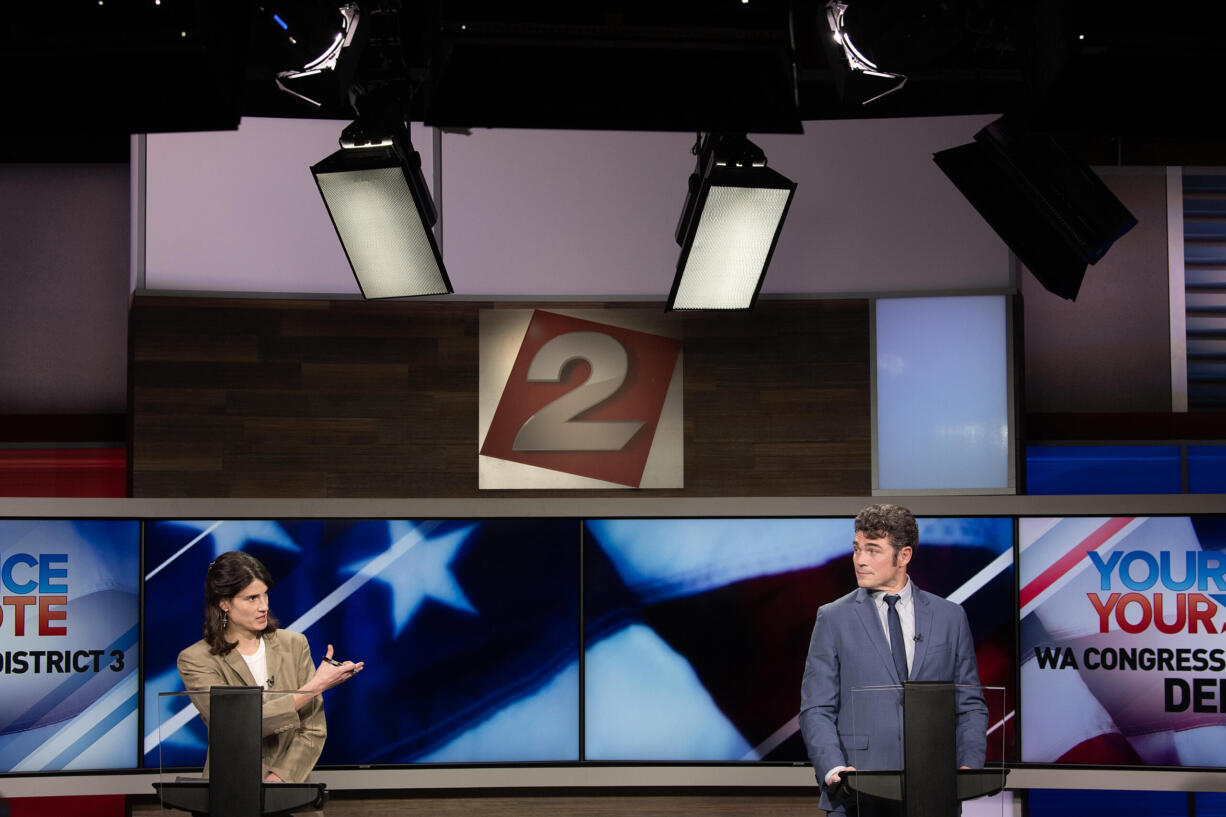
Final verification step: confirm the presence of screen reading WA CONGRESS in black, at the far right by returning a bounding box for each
[1019,516,1226,767]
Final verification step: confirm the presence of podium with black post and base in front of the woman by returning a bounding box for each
[153,687,325,817]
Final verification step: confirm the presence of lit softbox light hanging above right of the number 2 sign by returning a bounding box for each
[667,134,796,310]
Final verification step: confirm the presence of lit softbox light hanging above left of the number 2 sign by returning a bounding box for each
[310,123,452,299]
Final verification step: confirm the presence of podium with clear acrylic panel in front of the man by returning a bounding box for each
[832,681,1008,817]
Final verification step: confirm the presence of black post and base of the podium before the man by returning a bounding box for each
[832,681,1009,817]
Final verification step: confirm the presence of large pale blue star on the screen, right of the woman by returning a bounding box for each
[342,520,477,635]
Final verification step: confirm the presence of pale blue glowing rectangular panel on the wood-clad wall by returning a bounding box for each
[874,296,1013,493]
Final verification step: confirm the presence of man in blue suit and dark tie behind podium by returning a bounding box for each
[801,504,987,812]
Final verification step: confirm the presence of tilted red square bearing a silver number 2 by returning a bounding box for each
[481,309,680,488]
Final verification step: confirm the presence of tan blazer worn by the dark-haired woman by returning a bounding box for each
[179,629,327,783]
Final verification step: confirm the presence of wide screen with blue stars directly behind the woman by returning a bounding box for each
[143,519,579,767]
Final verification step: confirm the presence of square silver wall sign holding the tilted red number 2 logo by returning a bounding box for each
[478,309,683,488]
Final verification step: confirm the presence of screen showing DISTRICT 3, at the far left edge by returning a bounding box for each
[0,519,140,773]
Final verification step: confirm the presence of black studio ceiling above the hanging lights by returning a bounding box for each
[0,0,1226,164]
